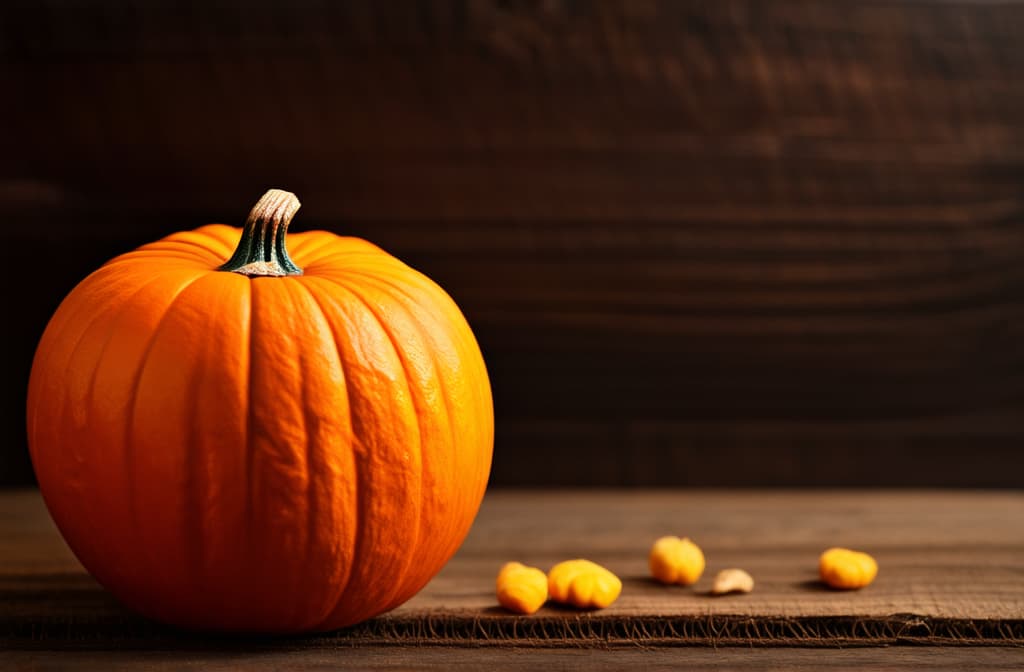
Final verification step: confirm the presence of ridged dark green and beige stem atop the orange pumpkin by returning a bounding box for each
[217,190,302,277]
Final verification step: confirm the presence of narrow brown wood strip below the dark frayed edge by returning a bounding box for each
[0,646,1024,672]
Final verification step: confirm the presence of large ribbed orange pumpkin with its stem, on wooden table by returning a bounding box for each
[28,190,494,633]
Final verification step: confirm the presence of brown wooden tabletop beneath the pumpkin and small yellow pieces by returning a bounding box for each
[0,491,1024,669]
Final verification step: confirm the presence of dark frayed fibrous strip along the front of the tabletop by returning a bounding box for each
[0,612,1024,648]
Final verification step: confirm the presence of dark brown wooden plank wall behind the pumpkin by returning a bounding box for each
[0,0,1024,487]
